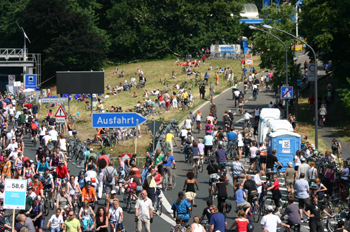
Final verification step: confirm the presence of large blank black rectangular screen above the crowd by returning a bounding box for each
[56,71,105,94]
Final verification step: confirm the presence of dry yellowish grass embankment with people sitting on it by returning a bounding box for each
[39,57,261,155]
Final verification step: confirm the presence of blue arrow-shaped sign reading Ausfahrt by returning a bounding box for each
[91,113,147,128]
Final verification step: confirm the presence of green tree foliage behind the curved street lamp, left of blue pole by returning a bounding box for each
[249,4,300,85]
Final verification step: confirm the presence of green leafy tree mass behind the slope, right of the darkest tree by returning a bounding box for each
[107,0,242,59]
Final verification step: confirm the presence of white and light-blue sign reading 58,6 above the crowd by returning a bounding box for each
[4,179,27,209]
